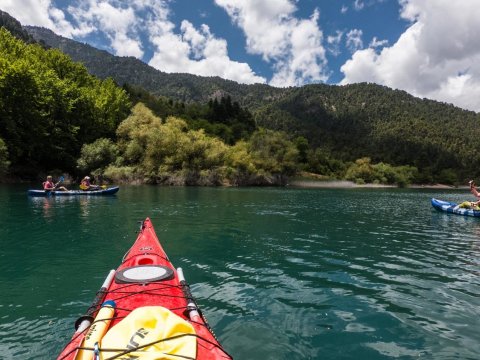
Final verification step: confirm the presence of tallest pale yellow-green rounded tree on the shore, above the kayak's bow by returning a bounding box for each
[114,103,231,184]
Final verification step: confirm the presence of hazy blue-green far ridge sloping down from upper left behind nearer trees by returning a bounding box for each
[24,26,285,104]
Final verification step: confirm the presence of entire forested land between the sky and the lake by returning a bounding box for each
[0,13,480,185]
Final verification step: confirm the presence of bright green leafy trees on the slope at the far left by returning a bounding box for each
[0,28,130,177]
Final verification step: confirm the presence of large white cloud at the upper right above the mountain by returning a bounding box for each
[341,0,480,112]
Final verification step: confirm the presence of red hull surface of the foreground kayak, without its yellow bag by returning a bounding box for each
[58,218,232,360]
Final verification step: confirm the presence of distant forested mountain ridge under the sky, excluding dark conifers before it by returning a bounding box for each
[3,14,480,183]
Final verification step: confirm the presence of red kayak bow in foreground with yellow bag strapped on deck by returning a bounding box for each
[58,218,232,360]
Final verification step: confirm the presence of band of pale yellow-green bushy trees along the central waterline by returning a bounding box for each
[78,103,298,185]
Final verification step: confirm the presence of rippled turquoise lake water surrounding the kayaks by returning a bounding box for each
[0,185,480,360]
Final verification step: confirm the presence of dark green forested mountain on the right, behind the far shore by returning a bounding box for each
[255,83,480,183]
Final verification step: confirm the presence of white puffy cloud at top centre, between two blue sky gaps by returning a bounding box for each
[215,0,327,86]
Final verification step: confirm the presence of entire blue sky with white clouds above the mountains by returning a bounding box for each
[0,0,480,112]
